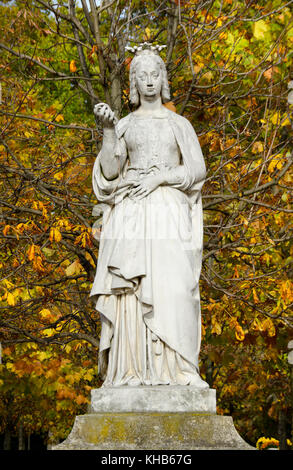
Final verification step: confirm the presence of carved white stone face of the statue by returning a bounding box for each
[135,57,162,100]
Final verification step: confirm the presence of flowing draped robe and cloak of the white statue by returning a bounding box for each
[90,110,206,386]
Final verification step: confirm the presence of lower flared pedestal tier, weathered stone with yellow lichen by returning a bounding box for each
[52,412,253,450]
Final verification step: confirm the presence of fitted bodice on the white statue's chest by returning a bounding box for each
[124,116,180,170]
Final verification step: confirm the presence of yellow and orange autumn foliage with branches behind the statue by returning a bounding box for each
[0,0,293,444]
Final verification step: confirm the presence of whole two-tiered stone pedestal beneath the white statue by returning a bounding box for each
[53,386,252,450]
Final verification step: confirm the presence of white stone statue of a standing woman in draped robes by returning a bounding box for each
[90,47,208,388]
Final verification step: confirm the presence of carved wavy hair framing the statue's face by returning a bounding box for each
[129,49,170,106]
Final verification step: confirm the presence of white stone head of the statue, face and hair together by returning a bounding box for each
[130,49,170,106]
